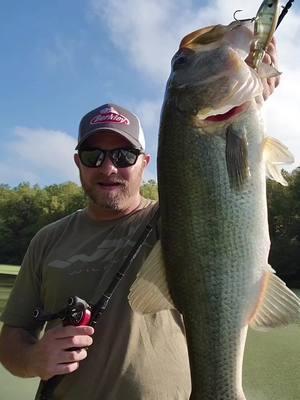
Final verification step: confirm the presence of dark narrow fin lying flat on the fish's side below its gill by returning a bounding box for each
[226,125,249,190]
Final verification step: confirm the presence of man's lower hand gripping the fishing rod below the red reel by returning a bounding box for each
[30,325,94,380]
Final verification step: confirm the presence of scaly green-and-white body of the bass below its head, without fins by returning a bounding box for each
[158,104,269,400]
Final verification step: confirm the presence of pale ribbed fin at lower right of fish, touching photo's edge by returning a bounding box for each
[249,272,300,330]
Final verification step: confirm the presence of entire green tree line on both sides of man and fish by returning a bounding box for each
[0,173,300,287]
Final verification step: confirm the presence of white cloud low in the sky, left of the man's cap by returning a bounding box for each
[0,127,78,184]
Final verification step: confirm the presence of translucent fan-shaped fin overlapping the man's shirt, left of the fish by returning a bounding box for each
[128,241,175,314]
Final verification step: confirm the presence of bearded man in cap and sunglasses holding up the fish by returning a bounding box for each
[0,43,278,400]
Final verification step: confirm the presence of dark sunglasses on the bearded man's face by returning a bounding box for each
[78,148,144,168]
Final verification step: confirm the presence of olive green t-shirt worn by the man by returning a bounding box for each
[1,200,190,400]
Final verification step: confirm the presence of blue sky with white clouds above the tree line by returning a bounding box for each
[0,0,300,186]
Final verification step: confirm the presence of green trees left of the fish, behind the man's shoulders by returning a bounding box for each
[0,180,158,265]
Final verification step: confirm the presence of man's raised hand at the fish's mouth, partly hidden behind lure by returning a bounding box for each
[246,37,280,100]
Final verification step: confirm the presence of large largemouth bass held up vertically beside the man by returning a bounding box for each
[129,22,300,400]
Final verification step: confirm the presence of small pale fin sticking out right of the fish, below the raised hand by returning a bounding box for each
[263,137,294,186]
